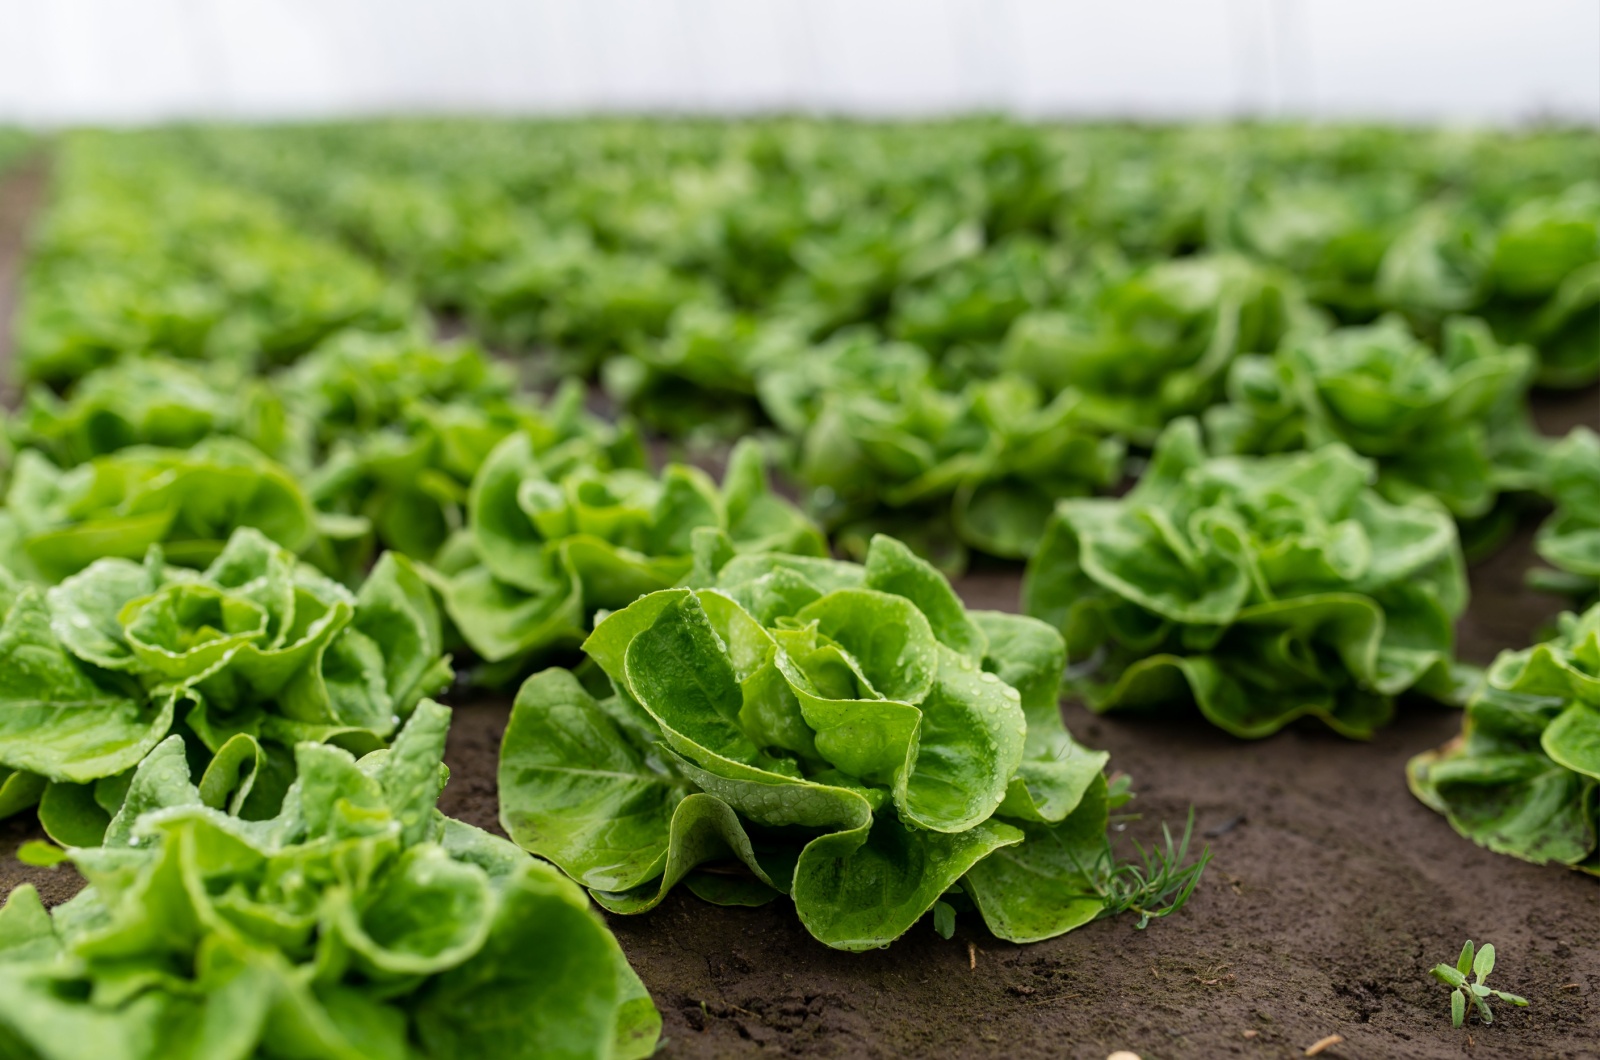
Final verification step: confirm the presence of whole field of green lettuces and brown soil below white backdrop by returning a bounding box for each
[0,118,1600,1060]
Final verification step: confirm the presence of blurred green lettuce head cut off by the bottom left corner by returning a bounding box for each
[0,700,661,1060]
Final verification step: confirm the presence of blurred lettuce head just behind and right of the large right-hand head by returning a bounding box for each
[1205,317,1549,557]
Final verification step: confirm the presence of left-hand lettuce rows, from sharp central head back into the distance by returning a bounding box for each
[0,130,1164,1058]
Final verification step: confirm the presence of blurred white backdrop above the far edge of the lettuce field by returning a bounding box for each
[0,0,1600,125]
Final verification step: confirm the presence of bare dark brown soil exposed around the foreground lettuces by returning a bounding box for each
[0,157,1600,1060]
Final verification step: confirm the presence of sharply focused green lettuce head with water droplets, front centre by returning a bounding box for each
[499,528,1125,951]
